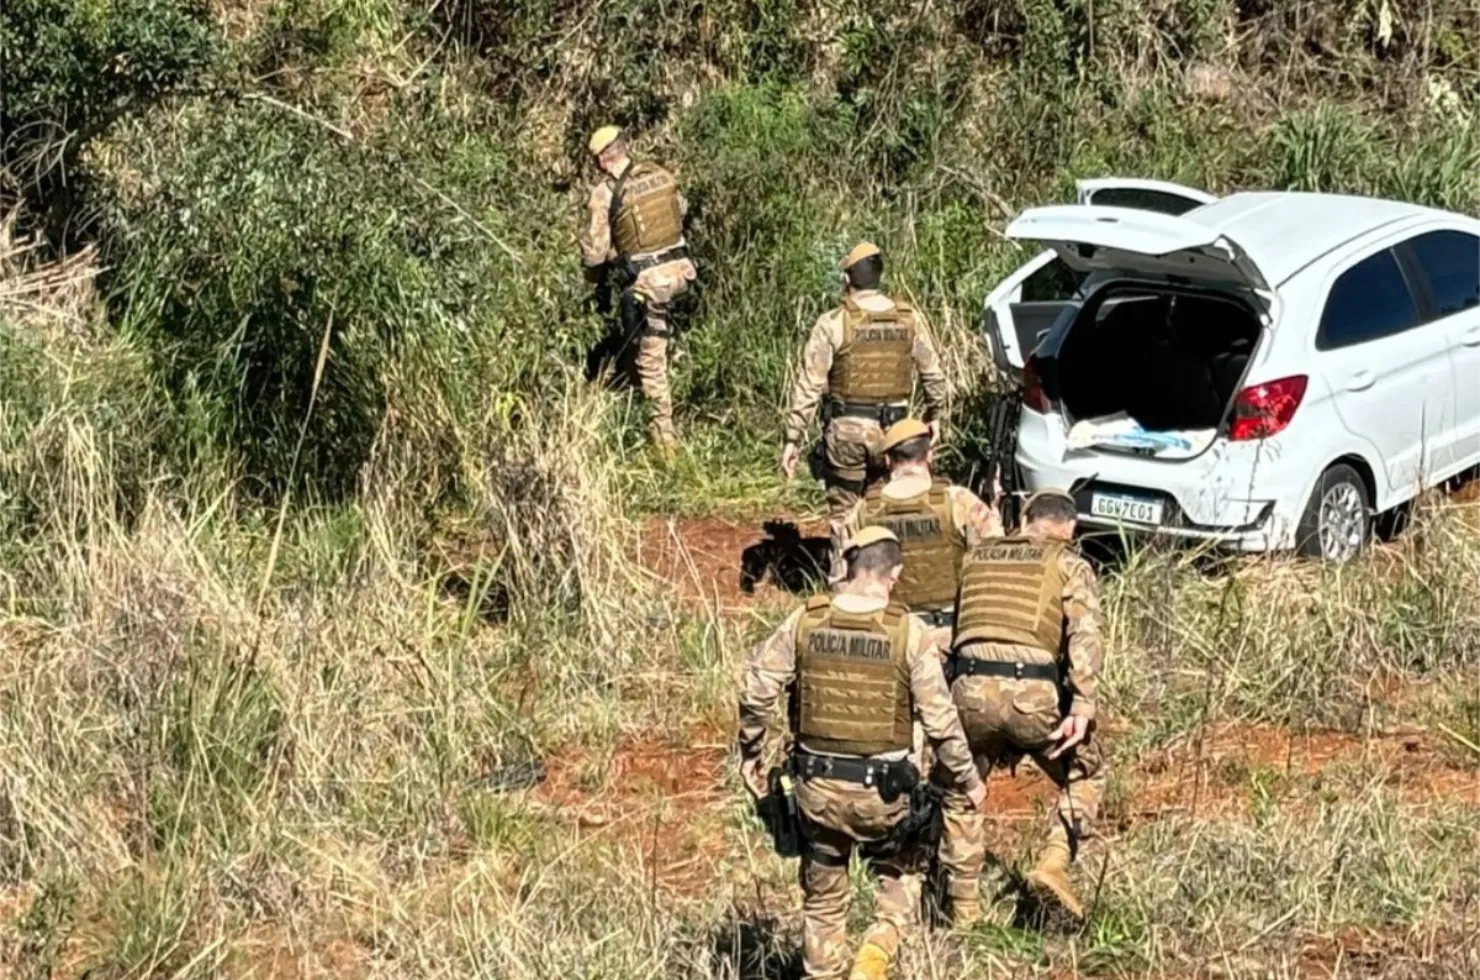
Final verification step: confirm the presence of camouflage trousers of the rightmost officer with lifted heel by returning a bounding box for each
[940,677,1109,907]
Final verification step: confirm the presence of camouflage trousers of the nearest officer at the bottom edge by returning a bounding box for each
[796,779,924,980]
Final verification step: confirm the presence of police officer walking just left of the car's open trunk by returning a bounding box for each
[781,241,947,577]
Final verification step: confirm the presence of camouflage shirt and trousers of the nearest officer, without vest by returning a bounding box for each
[740,595,980,977]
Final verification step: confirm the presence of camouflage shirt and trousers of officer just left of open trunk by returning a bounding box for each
[786,301,949,574]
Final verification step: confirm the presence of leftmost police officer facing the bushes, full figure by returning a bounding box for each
[580,126,697,456]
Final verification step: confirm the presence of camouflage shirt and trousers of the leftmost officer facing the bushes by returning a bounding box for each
[580,165,699,446]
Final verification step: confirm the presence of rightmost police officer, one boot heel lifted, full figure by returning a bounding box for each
[940,490,1107,925]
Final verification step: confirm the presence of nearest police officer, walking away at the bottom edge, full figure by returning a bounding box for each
[739,527,986,980]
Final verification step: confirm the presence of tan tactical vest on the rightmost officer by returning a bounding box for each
[953,537,1066,657]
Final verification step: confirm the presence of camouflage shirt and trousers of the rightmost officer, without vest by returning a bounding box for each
[940,549,1109,921]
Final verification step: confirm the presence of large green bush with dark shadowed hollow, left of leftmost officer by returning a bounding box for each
[89,90,592,496]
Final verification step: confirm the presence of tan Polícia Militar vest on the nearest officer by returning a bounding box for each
[792,595,913,756]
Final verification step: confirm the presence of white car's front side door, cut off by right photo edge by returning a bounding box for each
[1402,227,1480,477]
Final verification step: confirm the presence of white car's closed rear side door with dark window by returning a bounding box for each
[1314,243,1455,508]
